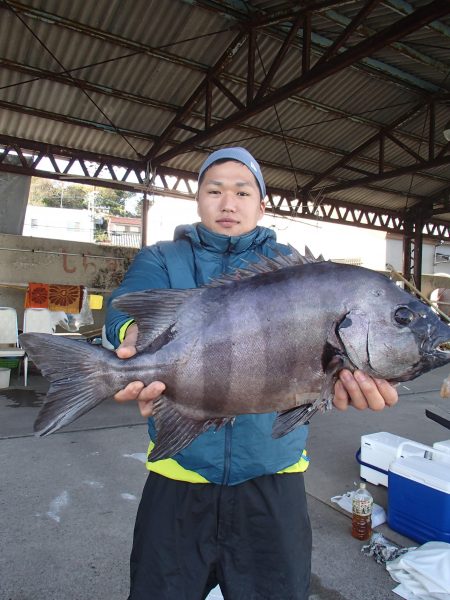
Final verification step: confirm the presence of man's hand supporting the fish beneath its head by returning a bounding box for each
[333,369,398,410]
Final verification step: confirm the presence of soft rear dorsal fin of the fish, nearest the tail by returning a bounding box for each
[113,288,202,352]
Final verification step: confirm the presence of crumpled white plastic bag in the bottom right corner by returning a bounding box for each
[386,542,450,600]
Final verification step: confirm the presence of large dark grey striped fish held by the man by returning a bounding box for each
[20,254,450,460]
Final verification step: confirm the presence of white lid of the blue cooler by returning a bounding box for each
[389,456,450,494]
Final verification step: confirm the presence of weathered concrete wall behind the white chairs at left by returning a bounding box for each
[0,234,137,330]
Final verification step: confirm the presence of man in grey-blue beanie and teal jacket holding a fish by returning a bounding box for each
[107,148,397,600]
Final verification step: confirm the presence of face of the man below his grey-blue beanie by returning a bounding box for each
[197,161,265,236]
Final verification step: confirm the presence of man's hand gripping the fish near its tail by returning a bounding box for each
[114,323,166,417]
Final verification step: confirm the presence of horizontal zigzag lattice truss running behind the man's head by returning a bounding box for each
[0,136,450,241]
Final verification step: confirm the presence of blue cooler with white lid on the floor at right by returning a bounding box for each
[388,456,450,543]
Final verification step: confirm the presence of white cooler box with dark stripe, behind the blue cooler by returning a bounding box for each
[358,431,411,487]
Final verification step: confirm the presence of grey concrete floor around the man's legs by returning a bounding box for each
[0,358,450,600]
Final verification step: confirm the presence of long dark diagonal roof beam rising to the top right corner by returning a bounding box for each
[153,0,449,164]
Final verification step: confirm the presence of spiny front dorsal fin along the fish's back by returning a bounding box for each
[208,245,325,287]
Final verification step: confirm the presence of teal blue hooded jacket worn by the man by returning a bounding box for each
[106,224,308,485]
